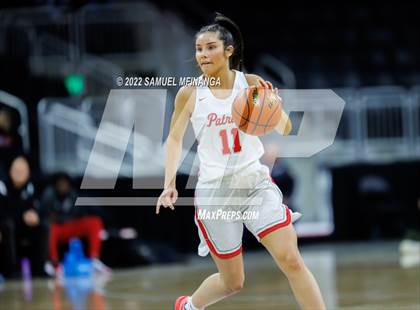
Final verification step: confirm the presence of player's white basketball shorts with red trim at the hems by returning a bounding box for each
[195,161,291,259]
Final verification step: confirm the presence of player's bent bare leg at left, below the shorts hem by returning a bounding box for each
[191,254,245,309]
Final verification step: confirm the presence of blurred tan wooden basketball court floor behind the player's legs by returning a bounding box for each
[0,242,420,310]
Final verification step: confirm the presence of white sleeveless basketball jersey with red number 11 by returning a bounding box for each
[190,70,264,182]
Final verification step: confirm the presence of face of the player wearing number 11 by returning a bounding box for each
[195,32,231,75]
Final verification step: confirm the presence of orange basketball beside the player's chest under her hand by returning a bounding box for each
[232,86,281,136]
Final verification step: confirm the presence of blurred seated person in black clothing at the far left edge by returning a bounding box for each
[0,156,47,276]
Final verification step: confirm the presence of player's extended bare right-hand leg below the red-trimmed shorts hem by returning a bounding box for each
[261,224,325,309]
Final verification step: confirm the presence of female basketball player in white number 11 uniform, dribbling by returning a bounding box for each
[156,14,325,310]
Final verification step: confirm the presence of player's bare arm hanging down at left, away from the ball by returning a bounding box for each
[156,86,194,214]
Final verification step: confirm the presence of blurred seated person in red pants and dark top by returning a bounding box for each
[41,173,111,275]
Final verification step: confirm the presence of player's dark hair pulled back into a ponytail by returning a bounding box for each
[195,12,244,70]
